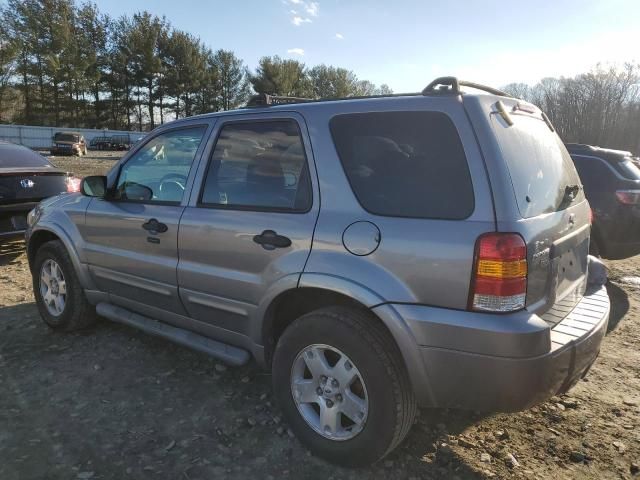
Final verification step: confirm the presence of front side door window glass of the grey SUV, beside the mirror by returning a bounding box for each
[115,126,207,202]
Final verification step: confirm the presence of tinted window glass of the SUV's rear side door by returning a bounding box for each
[202,120,311,211]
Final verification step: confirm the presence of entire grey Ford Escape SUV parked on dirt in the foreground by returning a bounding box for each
[26,77,609,465]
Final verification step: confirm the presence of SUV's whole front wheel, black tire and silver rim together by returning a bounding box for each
[32,240,97,331]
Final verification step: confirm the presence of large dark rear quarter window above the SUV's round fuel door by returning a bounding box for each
[330,112,474,220]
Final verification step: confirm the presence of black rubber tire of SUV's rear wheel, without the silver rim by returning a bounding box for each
[272,307,417,467]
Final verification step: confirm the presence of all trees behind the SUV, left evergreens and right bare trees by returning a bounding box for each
[0,0,640,152]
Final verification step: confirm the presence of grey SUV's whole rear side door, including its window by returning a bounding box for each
[178,114,318,335]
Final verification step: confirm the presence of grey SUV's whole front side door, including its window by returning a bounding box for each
[82,121,211,315]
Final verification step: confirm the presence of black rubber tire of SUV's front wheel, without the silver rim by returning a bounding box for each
[32,240,97,332]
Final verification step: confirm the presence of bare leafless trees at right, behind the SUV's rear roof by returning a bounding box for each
[503,64,640,154]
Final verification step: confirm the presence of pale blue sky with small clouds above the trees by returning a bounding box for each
[96,0,640,92]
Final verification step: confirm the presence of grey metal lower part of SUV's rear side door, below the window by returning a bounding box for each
[178,207,316,334]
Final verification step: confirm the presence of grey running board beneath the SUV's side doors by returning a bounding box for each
[96,302,250,366]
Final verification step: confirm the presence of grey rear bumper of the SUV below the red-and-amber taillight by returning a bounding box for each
[397,287,610,412]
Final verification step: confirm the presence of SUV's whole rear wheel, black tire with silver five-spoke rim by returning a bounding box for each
[273,308,417,466]
